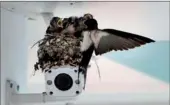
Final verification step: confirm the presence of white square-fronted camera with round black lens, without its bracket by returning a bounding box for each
[45,66,84,98]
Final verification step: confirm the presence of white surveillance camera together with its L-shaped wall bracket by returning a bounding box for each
[5,66,84,105]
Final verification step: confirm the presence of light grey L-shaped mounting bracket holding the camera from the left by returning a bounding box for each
[5,79,76,105]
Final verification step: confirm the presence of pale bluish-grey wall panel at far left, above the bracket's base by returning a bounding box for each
[1,8,28,105]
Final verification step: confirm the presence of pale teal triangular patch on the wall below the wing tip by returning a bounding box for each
[104,41,170,83]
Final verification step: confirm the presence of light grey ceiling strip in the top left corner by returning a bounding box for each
[1,1,80,16]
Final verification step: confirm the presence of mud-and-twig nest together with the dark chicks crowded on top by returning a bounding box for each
[34,14,93,71]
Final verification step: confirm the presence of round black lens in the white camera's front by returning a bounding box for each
[54,73,73,91]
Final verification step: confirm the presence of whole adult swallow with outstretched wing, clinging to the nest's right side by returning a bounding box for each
[62,17,155,88]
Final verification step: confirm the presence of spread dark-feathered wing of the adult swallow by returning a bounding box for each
[91,29,155,55]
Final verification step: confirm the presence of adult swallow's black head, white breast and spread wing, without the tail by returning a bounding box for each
[81,19,155,55]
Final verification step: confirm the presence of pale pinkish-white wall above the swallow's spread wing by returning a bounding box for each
[54,2,169,40]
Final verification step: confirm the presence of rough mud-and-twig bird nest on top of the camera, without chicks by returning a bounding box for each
[34,35,82,70]
